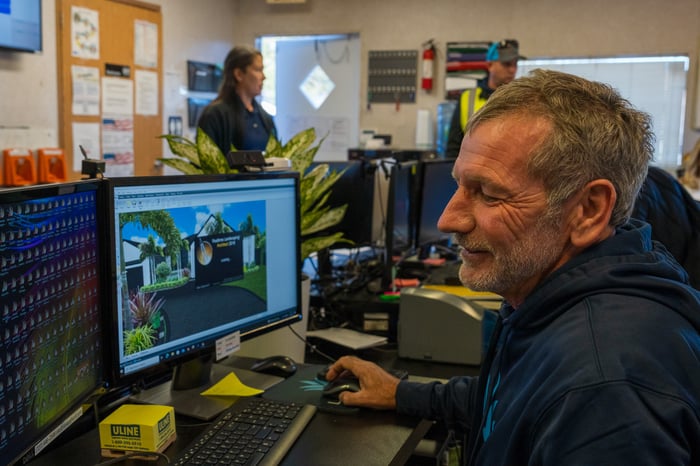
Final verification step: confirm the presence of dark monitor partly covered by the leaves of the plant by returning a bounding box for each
[309,160,376,248]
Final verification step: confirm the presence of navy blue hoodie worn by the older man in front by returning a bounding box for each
[396,221,700,465]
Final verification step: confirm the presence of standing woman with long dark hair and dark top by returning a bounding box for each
[198,46,277,154]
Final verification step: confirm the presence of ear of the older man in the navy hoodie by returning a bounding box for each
[569,179,617,248]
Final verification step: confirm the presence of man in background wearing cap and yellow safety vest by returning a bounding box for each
[446,39,525,158]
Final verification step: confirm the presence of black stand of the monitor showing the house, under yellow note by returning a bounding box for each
[128,359,284,421]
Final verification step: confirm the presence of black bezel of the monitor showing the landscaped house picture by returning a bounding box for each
[104,172,302,388]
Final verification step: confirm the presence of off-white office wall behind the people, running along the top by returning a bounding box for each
[0,0,700,163]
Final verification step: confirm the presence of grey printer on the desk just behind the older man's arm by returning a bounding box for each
[397,286,502,365]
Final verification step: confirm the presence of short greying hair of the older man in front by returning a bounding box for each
[466,69,654,226]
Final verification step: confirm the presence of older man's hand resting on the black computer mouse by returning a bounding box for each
[326,356,399,409]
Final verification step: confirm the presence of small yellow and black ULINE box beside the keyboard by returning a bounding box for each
[100,404,176,456]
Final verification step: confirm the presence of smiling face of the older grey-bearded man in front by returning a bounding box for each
[438,117,568,306]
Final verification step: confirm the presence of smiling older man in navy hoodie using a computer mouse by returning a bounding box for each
[327,70,700,465]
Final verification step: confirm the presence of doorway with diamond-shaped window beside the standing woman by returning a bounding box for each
[257,34,361,161]
